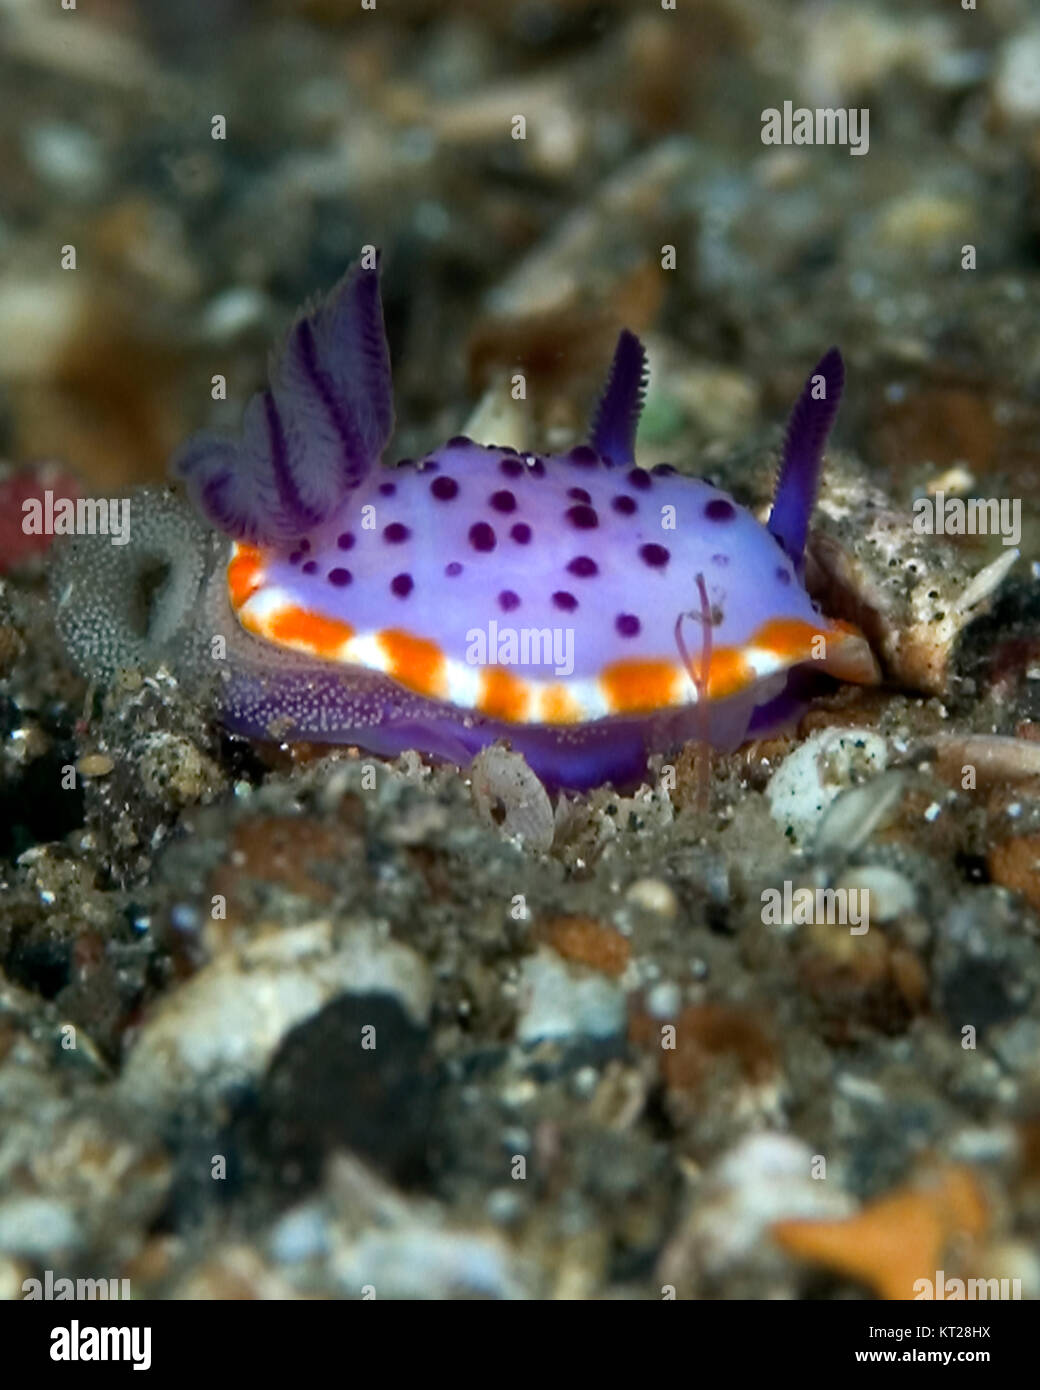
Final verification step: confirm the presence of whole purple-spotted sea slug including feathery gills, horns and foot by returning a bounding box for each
[48,259,877,790]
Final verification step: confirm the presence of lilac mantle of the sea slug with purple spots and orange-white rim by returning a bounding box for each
[228,455,867,726]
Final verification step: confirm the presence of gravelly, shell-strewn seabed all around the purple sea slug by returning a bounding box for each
[0,0,1040,1300]
